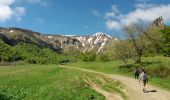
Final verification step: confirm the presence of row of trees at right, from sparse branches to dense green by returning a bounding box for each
[114,23,170,66]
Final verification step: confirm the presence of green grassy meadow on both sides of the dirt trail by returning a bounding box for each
[0,56,170,100]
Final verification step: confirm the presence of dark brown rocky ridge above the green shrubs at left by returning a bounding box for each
[0,27,59,50]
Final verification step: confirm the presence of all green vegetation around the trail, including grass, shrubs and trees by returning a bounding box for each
[0,18,170,100]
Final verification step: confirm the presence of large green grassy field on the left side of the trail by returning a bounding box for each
[0,65,127,100]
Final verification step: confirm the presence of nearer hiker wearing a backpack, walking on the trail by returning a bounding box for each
[139,69,148,92]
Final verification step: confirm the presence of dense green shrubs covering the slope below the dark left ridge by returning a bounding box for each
[0,41,69,64]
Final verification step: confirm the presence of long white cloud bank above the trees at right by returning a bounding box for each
[106,4,170,29]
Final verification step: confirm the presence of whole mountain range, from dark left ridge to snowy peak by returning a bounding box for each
[0,27,117,53]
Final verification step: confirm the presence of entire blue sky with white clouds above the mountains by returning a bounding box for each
[0,0,170,36]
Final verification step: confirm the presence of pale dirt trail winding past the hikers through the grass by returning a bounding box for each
[62,67,170,100]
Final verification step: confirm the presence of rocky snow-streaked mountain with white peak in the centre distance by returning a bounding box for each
[43,32,117,53]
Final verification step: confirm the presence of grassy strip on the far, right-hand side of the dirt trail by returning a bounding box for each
[66,56,170,90]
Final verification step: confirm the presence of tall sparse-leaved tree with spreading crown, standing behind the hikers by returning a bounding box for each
[123,23,147,63]
